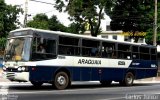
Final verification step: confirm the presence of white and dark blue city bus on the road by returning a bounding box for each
[3,28,158,89]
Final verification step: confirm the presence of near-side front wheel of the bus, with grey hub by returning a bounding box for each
[53,72,69,90]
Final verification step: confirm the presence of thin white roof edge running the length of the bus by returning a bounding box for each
[10,27,156,48]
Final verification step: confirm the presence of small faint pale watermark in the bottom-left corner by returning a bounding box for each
[0,94,18,100]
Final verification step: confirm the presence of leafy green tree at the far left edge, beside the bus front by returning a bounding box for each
[0,0,23,37]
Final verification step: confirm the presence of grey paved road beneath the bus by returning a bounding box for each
[0,82,160,100]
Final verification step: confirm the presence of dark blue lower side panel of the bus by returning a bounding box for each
[29,62,157,82]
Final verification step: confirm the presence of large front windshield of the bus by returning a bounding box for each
[4,37,31,61]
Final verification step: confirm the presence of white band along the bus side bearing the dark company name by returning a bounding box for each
[36,56,132,68]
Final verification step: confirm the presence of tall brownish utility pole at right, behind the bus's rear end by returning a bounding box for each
[153,0,158,46]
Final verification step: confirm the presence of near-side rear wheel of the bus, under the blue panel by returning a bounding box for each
[120,72,134,86]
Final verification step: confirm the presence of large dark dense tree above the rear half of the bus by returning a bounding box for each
[105,0,154,42]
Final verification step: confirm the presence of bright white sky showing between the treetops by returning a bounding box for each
[5,0,110,30]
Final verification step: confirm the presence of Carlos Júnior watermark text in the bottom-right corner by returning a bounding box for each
[125,94,160,100]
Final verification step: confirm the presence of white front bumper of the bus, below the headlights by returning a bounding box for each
[3,72,29,82]
